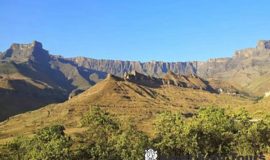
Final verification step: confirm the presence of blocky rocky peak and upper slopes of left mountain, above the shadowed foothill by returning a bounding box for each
[0,41,106,93]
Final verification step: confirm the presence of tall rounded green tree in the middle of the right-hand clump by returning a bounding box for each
[186,107,235,156]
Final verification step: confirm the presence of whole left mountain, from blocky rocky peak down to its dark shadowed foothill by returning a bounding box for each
[0,41,106,120]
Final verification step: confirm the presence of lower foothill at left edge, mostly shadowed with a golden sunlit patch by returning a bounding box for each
[0,62,64,121]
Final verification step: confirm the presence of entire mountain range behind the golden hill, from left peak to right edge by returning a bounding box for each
[0,41,270,120]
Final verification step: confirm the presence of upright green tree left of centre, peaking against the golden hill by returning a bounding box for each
[77,107,119,160]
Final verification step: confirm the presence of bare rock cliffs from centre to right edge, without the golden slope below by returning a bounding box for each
[69,41,270,78]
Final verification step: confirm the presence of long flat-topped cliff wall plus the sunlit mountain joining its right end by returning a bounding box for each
[68,41,270,96]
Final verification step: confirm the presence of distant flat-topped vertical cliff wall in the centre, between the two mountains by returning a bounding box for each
[69,57,198,77]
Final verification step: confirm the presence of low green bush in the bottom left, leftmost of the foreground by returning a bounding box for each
[7,125,72,160]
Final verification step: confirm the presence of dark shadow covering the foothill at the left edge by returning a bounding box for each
[0,80,66,121]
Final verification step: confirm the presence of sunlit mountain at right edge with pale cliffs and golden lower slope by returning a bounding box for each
[197,41,270,96]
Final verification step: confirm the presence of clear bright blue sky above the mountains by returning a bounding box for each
[0,0,270,61]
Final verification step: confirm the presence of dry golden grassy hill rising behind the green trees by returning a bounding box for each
[0,77,264,143]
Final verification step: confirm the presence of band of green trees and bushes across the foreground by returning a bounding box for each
[0,107,270,160]
